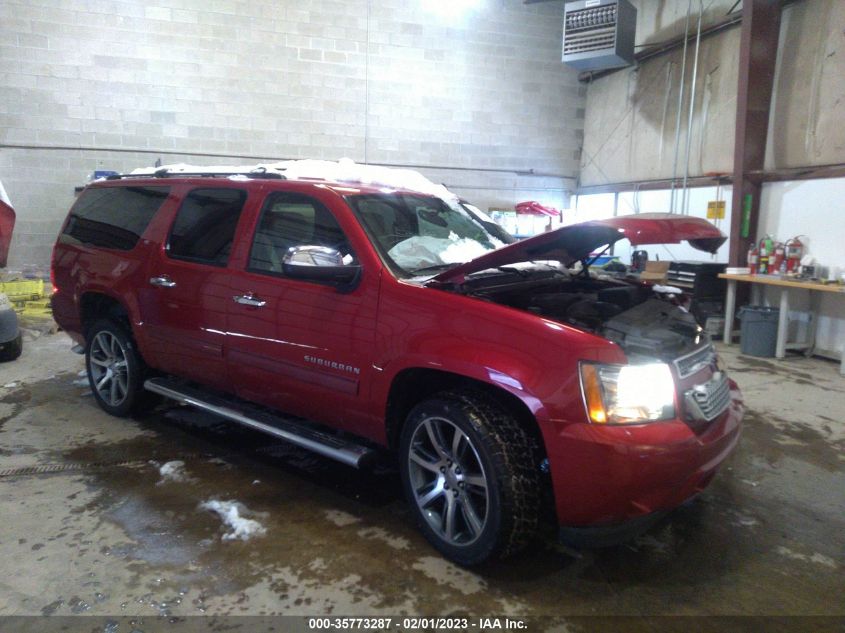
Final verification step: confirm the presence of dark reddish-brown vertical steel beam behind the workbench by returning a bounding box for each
[729,0,782,266]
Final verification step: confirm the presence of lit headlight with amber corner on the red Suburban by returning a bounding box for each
[581,363,675,424]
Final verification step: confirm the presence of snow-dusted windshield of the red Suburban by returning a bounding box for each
[347,193,504,277]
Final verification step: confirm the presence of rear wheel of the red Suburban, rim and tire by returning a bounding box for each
[85,319,146,417]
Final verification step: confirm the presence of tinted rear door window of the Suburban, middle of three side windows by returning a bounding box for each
[167,188,246,266]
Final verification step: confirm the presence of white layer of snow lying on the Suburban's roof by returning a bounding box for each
[131,158,458,200]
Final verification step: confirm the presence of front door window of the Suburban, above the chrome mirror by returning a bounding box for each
[249,193,355,274]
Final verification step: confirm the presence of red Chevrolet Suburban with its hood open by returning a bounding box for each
[53,165,742,565]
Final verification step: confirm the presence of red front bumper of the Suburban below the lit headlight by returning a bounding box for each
[548,384,743,528]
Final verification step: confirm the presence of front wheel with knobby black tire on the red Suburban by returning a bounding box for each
[400,392,541,566]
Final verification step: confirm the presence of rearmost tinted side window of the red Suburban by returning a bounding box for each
[61,187,170,251]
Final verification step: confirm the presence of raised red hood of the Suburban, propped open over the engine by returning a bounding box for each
[434,213,728,283]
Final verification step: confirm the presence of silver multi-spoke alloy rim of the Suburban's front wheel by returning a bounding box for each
[408,417,490,545]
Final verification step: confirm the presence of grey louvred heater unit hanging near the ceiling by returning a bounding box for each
[563,0,637,70]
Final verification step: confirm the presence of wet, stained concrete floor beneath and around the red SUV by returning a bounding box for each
[0,334,845,630]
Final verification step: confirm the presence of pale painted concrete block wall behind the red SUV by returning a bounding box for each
[0,0,586,268]
